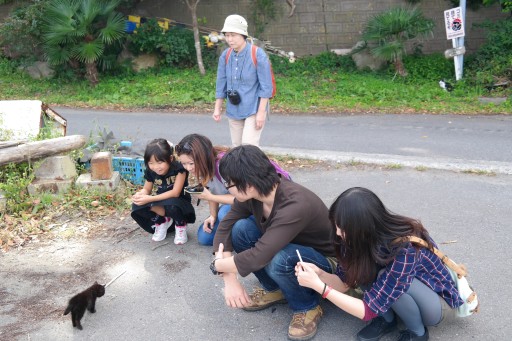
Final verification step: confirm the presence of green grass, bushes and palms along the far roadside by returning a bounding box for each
[0,0,512,114]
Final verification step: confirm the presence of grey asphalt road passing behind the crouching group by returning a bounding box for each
[54,108,512,174]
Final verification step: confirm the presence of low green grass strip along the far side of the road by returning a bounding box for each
[0,58,512,114]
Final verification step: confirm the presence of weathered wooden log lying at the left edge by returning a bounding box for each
[0,135,87,166]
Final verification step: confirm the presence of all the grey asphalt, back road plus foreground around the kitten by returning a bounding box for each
[0,108,512,341]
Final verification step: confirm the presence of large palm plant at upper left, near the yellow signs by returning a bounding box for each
[42,0,126,85]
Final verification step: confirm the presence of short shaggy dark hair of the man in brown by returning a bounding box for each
[219,145,280,196]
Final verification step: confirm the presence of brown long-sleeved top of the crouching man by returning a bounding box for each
[213,179,335,277]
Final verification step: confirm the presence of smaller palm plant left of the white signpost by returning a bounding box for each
[363,7,434,77]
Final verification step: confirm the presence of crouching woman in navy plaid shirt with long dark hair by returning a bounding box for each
[295,187,463,341]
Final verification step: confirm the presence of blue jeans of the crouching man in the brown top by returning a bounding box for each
[232,219,332,313]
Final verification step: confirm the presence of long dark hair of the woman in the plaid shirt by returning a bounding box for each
[329,187,432,288]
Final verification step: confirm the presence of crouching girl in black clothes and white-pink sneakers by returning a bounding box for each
[132,139,196,244]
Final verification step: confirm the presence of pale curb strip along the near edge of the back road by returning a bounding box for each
[262,147,512,175]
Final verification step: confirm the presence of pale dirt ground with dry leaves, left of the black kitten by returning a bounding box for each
[0,212,138,340]
